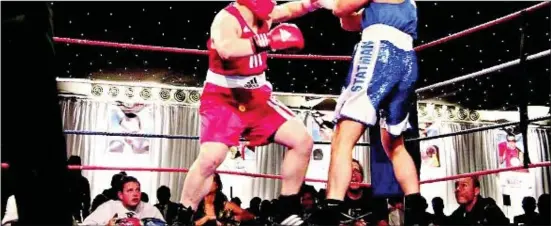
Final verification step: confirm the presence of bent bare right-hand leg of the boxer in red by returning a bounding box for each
[274,119,314,195]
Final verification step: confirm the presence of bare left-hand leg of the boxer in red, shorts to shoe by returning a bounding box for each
[180,142,229,210]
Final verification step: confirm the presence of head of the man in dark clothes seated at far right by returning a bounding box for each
[455,177,480,206]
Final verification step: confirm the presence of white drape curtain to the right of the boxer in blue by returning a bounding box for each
[421,122,551,219]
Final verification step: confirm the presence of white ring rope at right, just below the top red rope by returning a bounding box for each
[415,49,551,93]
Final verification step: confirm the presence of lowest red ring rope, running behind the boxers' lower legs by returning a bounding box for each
[2,161,551,187]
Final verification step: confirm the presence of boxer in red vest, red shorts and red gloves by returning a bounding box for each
[180,0,328,225]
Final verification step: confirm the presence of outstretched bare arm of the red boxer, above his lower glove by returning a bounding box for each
[270,0,319,23]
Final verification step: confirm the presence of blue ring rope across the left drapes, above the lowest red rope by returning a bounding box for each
[63,130,369,146]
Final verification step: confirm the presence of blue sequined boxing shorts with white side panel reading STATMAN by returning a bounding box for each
[335,40,417,135]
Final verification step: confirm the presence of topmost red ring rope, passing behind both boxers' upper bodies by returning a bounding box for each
[54,1,550,61]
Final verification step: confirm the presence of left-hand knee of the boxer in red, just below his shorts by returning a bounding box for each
[197,142,229,176]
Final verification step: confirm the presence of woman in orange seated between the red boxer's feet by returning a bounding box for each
[194,173,255,226]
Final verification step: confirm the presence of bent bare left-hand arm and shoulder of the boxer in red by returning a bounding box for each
[210,11,255,59]
